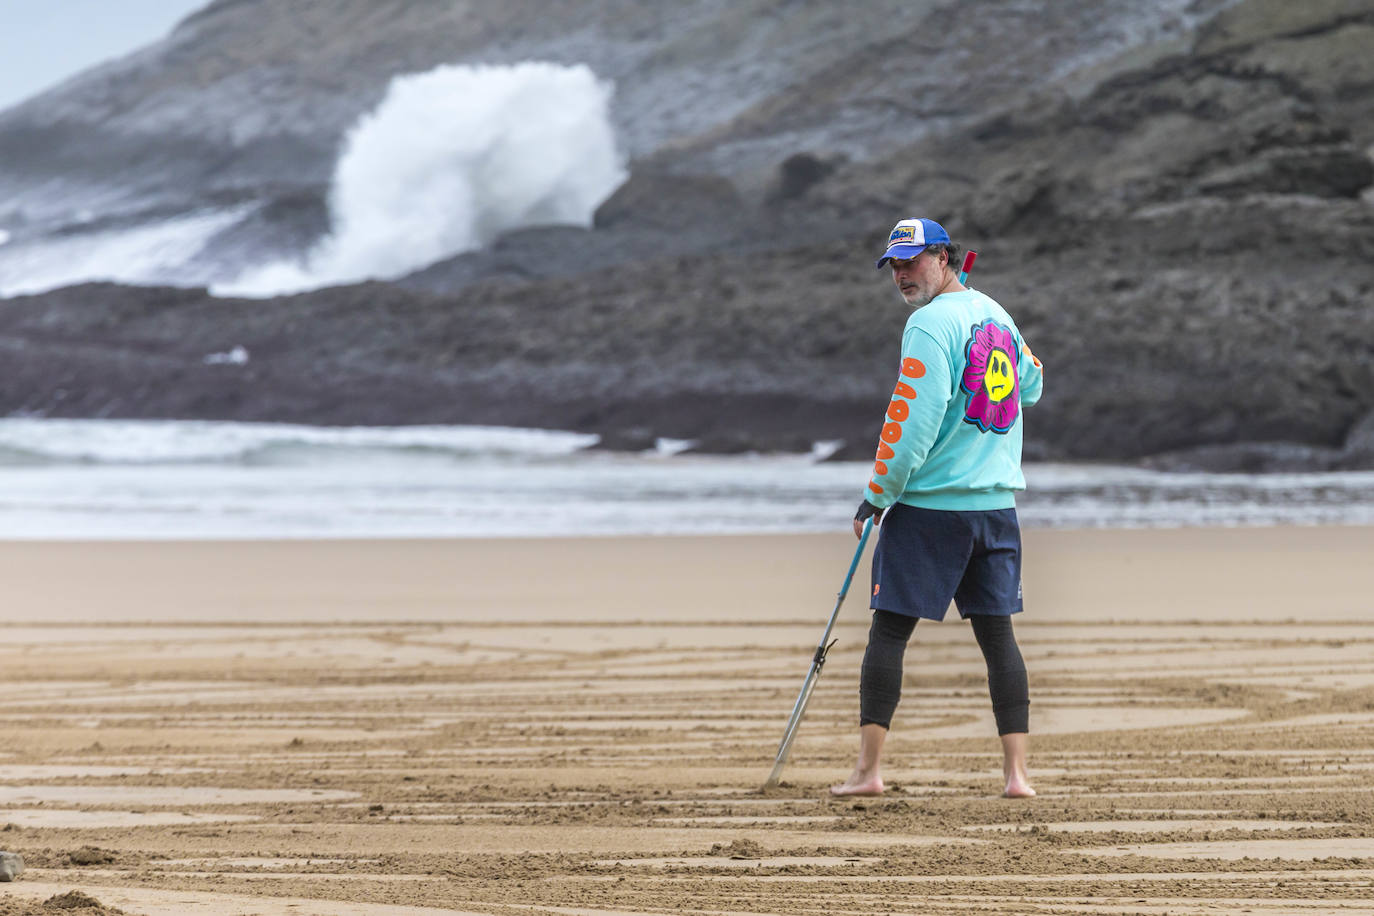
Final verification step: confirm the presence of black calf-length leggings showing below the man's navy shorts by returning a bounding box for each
[859,611,1031,735]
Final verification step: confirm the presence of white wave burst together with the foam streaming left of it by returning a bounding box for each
[0,62,628,297]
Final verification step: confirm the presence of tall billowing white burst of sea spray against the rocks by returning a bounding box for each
[214,63,625,295]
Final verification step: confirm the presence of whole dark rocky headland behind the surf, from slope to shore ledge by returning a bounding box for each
[0,0,1374,470]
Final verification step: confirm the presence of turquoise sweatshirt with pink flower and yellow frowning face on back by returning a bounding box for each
[864,290,1043,509]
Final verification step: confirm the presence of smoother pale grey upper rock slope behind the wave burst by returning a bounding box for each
[0,0,1236,241]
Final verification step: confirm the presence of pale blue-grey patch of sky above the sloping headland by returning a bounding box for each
[0,0,210,110]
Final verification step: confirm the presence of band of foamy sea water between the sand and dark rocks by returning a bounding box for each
[0,419,1374,540]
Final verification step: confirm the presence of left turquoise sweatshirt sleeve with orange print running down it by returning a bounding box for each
[864,327,952,509]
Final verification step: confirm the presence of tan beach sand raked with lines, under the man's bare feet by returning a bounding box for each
[0,527,1374,916]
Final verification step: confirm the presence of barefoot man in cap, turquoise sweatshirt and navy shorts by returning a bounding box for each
[830,220,1041,798]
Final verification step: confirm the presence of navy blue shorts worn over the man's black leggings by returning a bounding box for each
[870,503,1021,621]
